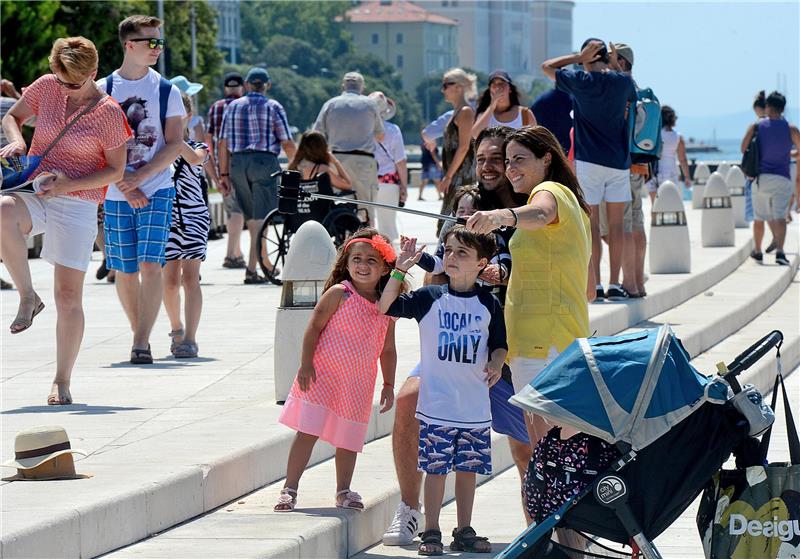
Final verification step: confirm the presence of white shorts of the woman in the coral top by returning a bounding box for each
[14,192,97,272]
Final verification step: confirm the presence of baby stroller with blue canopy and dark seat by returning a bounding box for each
[497,326,783,559]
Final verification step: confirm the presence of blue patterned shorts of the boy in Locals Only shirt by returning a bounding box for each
[417,421,492,475]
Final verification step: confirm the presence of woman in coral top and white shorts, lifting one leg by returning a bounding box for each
[0,37,131,405]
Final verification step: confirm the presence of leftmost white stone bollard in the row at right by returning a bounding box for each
[648,181,692,274]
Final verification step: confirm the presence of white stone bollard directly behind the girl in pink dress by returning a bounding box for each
[273,221,336,404]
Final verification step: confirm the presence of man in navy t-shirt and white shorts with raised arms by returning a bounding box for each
[542,39,636,300]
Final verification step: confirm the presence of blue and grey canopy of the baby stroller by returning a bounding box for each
[509,325,732,450]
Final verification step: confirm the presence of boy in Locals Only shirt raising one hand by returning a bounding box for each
[379,225,508,555]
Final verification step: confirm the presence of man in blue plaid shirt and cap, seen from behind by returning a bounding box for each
[219,68,295,284]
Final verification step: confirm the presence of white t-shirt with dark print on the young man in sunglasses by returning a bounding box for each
[97,68,186,201]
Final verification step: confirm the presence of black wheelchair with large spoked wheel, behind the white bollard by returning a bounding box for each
[257,171,363,285]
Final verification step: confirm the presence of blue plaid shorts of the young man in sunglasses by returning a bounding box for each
[103,188,175,274]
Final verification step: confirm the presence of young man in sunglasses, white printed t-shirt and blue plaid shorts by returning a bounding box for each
[97,15,186,365]
